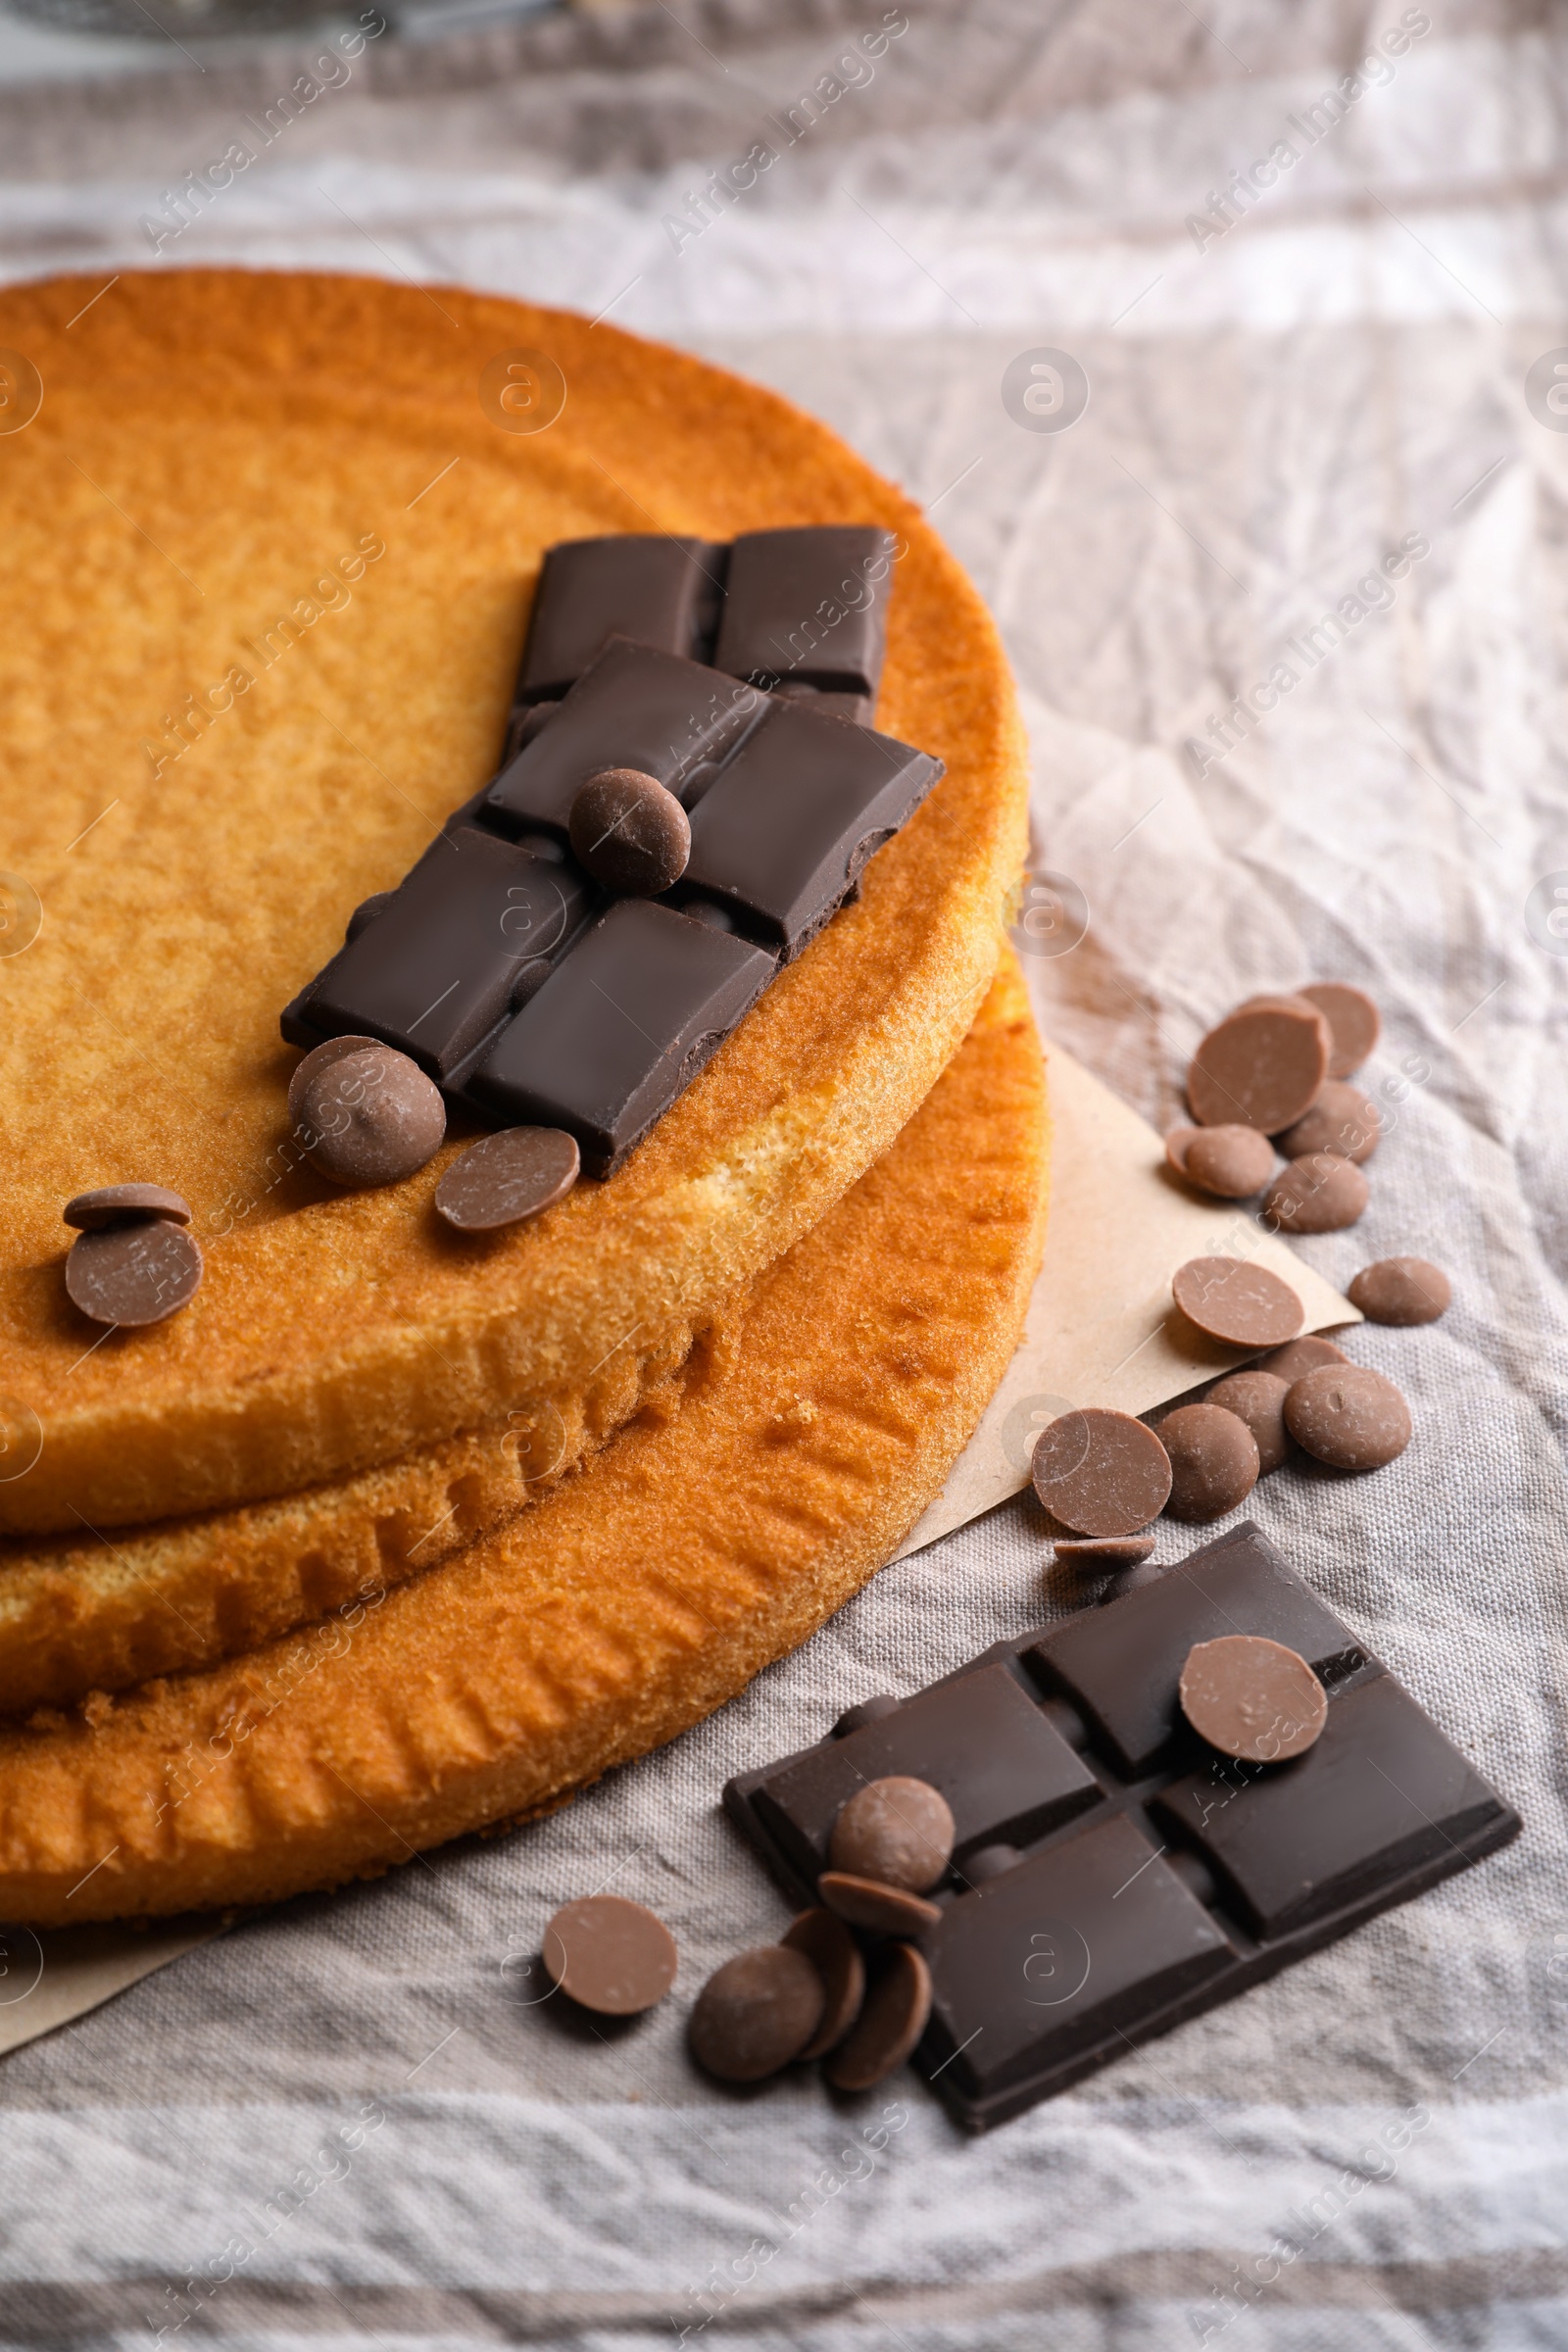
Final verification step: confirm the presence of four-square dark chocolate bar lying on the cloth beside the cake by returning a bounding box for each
[724,1524,1521,2131]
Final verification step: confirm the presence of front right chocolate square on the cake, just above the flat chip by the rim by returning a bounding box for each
[470,899,773,1176]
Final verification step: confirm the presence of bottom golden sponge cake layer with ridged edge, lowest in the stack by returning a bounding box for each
[0,957,1046,1927]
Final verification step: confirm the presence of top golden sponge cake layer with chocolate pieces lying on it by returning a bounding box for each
[0,270,1025,1534]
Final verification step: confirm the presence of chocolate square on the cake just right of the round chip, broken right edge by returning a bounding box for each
[676,701,943,959]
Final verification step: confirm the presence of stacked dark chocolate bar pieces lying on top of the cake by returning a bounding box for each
[282,524,943,1176]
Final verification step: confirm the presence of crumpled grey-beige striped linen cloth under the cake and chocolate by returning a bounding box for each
[0,0,1568,2352]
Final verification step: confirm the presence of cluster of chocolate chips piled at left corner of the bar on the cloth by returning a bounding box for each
[689,1768,955,2091]
